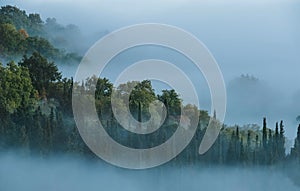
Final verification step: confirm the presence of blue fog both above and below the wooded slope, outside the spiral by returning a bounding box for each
[0,0,300,191]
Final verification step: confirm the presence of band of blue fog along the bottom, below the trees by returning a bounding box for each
[0,154,299,191]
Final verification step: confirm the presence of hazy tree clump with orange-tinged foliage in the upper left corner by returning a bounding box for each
[0,5,80,62]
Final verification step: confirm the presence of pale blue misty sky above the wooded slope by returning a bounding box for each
[0,0,300,138]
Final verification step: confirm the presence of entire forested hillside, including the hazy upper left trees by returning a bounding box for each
[0,6,300,169]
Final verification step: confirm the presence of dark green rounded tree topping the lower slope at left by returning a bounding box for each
[19,52,61,95]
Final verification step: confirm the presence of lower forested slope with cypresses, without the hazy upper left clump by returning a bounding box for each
[0,52,300,165]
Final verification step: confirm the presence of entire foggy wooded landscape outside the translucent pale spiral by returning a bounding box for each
[0,0,300,191]
